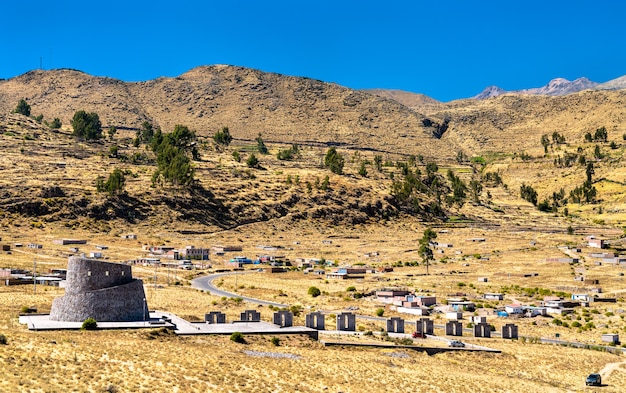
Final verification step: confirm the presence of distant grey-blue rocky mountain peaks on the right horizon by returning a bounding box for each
[471,75,626,100]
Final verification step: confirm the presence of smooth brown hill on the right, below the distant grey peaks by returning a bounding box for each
[424,91,626,154]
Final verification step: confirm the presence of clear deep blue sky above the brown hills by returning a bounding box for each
[0,0,626,101]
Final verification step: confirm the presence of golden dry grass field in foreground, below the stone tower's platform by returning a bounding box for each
[0,324,626,392]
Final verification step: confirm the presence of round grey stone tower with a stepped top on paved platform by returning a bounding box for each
[50,257,149,322]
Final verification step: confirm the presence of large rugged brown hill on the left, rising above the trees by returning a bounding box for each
[0,65,455,157]
